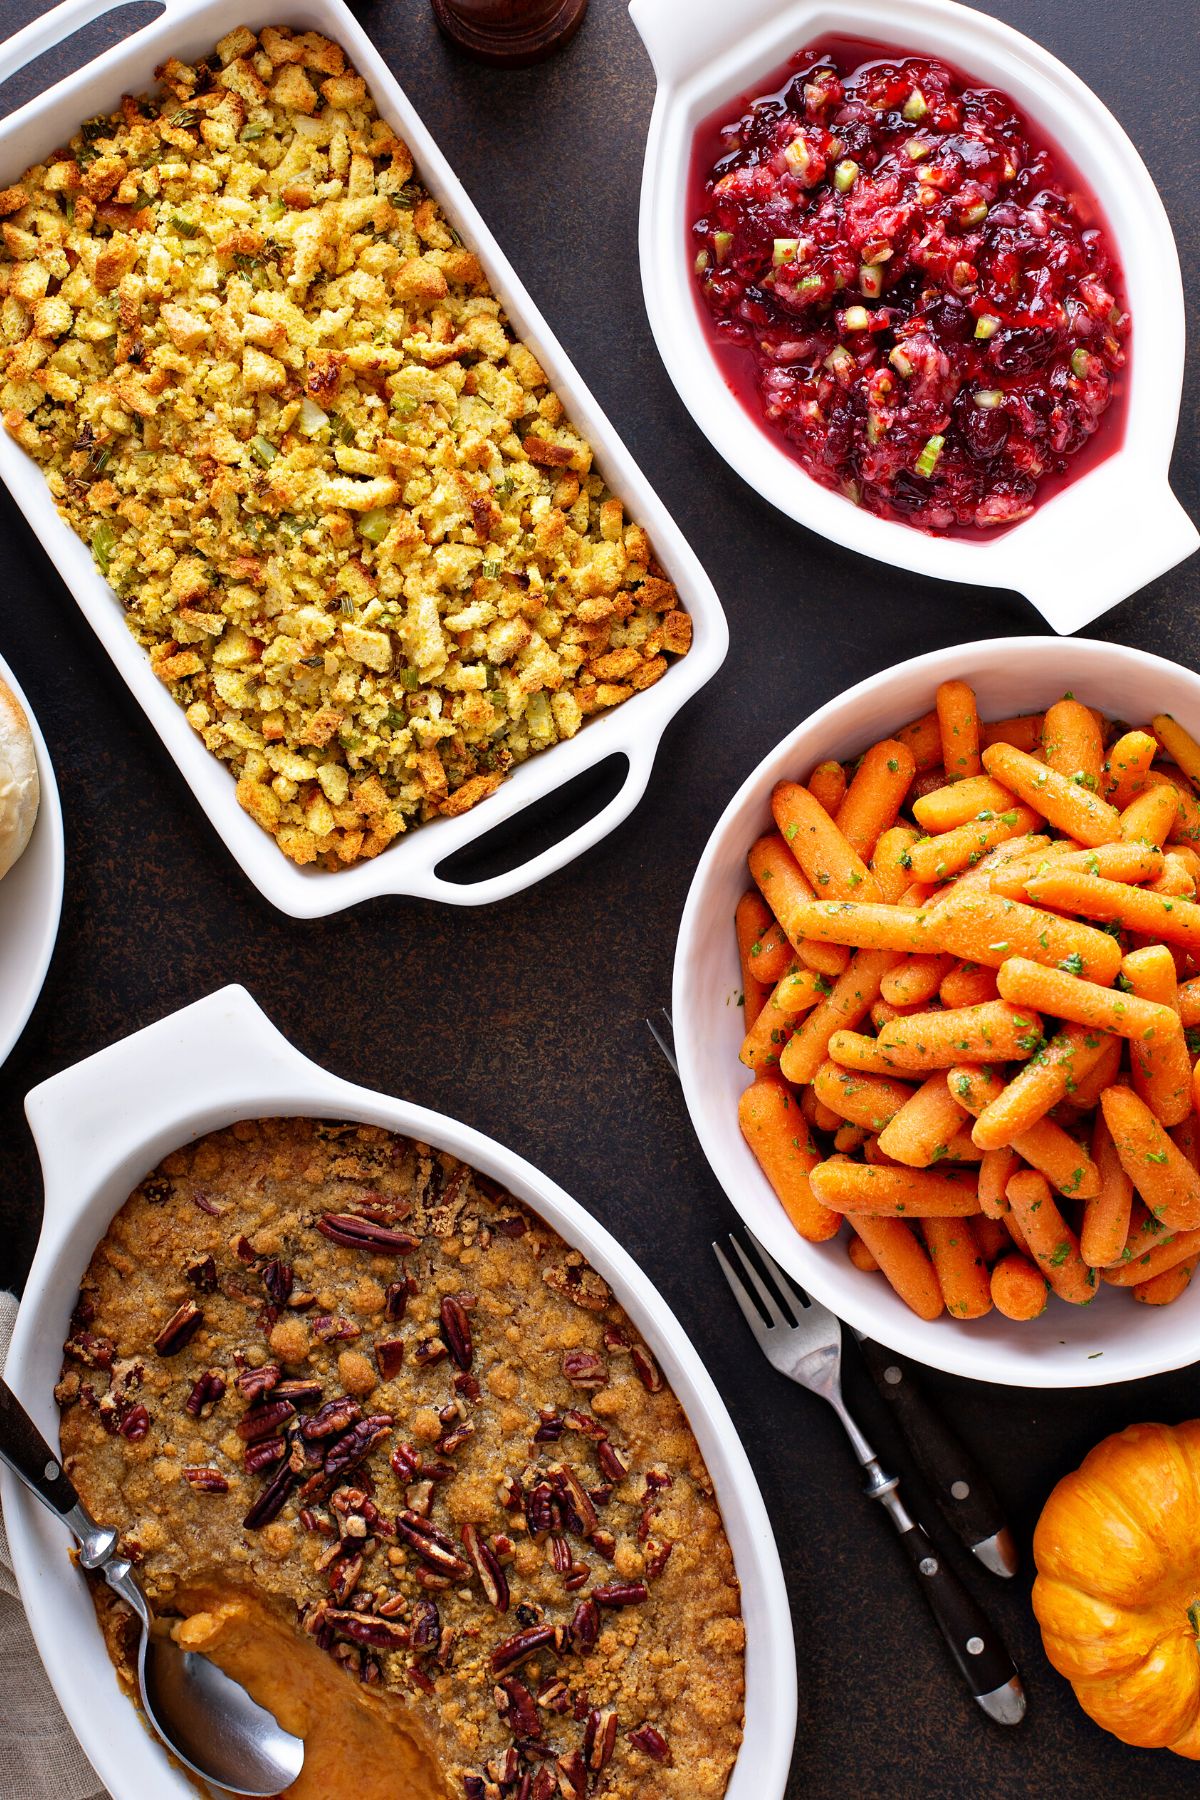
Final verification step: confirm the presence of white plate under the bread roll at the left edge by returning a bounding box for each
[0,657,67,1064]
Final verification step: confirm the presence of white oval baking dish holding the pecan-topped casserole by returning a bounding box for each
[0,986,797,1800]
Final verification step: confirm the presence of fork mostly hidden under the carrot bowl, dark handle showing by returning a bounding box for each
[646,1006,1020,1575]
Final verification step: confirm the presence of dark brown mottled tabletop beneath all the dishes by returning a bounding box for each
[0,0,1200,1800]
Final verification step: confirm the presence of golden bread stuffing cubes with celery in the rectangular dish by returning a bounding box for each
[0,27,691,868]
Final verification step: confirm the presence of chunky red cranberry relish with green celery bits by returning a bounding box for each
[693,47,1130,531]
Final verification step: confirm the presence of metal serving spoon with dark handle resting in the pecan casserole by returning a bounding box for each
[0,1379,304,1796]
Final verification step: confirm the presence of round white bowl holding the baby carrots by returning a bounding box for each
[671,637,1200,1388]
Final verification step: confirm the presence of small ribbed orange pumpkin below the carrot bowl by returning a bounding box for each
[1033,1418,1200,1759]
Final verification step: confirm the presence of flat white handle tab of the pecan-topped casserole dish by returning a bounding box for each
[25,986,329,1222]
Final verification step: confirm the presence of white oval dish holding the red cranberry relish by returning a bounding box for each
[630,0,1200,632]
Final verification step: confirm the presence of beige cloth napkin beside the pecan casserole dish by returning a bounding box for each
[0,1292,106,1800]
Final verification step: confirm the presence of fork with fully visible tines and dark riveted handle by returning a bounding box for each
[712,1231,1025,1724]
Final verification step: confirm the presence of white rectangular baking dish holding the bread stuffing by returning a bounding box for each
[0,0,729,918]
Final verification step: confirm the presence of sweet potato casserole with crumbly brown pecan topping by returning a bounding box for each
[58,1120,745,1800]
